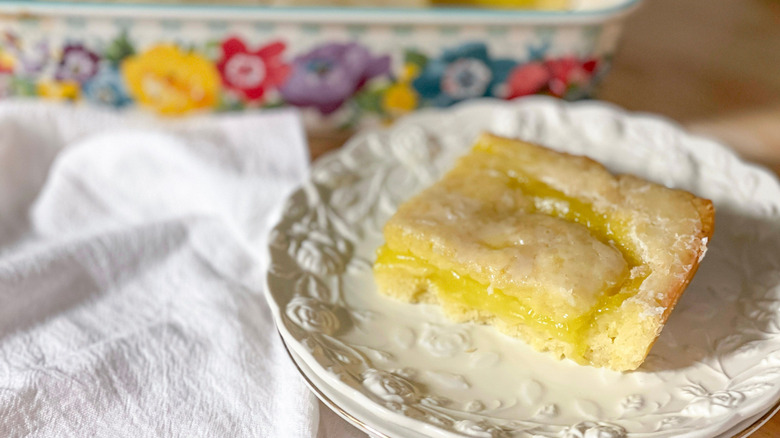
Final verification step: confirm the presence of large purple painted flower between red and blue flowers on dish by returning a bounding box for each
[280,43,390,114]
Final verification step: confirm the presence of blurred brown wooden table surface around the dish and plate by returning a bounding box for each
[311,0,780,438]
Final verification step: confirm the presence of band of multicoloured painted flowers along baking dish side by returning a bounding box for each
[0,31,609,125]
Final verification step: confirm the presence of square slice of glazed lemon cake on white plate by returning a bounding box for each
[374,134,714,371]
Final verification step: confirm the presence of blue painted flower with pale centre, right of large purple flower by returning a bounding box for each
[412,43,517,106]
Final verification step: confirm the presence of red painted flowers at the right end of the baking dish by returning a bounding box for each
[506,56,598,99]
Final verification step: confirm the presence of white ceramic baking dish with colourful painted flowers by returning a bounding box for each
[0,0,639,129]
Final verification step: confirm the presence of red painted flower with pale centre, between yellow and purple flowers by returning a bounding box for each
[217,38,290,100]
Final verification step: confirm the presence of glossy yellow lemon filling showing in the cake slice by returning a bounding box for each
[374,171,649,363]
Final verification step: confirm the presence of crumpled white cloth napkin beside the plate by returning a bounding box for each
[0,101,366,438]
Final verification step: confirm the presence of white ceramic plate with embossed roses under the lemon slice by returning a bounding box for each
[268,98,780,438]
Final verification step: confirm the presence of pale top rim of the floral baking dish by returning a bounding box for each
[0,0,642,25]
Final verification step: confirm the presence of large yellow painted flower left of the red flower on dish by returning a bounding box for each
[122,44,220,114]
